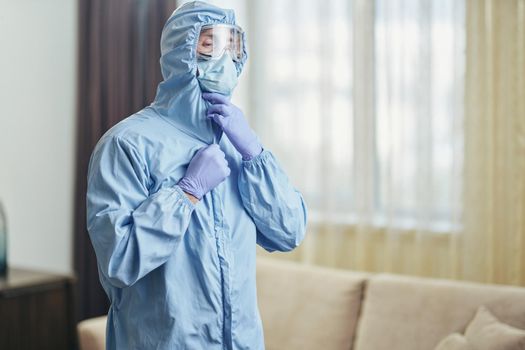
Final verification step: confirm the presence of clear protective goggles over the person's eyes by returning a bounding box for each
[197,24,243,62]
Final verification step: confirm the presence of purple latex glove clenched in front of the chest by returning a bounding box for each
[178,144,230,200]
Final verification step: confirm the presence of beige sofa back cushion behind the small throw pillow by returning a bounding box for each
[355,274,525,350]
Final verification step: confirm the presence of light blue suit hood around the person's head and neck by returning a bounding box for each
[151,1,247,144]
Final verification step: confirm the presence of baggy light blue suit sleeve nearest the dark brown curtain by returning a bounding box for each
[86,137,194,288]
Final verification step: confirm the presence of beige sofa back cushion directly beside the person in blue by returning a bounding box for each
[257,257,367,350]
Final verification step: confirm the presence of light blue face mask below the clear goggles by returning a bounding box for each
[197,51,238,96]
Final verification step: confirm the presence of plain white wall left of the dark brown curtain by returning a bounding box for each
[0,0,77,272]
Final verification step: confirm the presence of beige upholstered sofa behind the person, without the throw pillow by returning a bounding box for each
[78,257,525,350]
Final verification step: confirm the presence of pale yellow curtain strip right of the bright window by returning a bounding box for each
[460,0,525,285]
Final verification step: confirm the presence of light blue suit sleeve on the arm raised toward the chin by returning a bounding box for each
[238,149,307,252]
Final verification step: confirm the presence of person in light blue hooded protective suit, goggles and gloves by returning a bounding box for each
[87,1,307,350]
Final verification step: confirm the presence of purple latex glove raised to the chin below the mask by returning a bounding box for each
[202,92,262,160]
